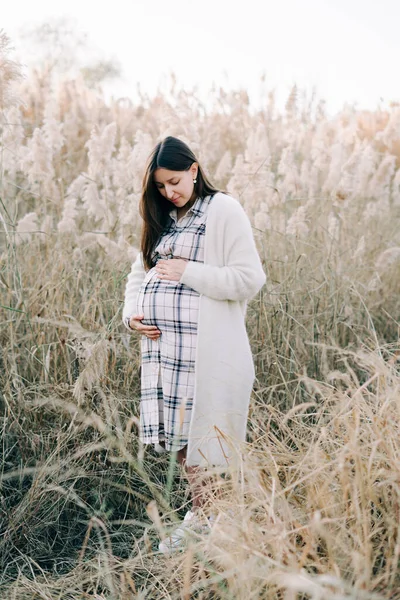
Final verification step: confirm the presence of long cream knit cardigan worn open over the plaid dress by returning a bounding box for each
[122,192,266,467]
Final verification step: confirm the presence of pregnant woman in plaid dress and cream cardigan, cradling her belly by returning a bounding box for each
[123,137,265,552]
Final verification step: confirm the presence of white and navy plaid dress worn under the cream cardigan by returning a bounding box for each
[133,196,212,450]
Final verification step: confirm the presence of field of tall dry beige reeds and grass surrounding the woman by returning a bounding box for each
[0,34,400,600]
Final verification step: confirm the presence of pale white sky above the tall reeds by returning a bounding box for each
[0,0,400,114]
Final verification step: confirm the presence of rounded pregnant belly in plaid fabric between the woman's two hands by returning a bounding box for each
[137,276,200,334]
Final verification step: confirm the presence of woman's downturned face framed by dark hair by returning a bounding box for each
[154,163,198,208]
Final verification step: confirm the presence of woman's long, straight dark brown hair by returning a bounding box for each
[139,136,219,270]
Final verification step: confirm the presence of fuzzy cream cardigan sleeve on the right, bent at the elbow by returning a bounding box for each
[180,196,266,301]
